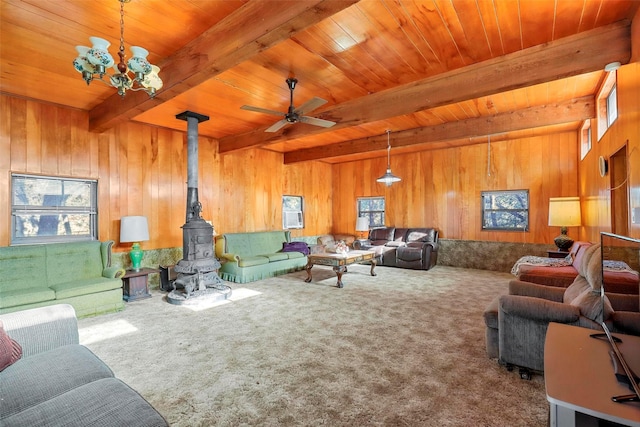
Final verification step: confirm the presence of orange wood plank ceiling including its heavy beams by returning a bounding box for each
[0,0,640,163]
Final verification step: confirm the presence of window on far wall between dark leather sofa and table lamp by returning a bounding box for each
[482,190,529,231]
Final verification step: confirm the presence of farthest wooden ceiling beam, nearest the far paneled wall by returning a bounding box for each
[284,96,596,164]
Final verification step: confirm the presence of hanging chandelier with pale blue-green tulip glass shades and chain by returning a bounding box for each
[73,0,162,98]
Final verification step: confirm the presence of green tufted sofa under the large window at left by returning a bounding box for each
[0,240,125,317]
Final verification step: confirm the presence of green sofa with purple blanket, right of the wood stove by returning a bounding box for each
[216,231,307,283]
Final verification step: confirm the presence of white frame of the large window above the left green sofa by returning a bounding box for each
[10,173,98,246]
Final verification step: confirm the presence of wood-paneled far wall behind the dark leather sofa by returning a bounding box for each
[333,132,578,243]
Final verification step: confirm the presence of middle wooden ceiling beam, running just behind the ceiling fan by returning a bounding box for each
[219,21,631,153]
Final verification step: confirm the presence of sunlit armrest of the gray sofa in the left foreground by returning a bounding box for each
[0,304,80,357]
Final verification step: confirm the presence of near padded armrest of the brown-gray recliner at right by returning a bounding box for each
[498,295,580,327]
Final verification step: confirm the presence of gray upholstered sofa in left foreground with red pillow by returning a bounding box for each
[0,304,168,427]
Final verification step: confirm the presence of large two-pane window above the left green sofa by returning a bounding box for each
[11,174,98,245]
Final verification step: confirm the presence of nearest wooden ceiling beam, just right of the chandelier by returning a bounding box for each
[89,0,358,132]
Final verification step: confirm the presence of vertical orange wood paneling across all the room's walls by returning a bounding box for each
[0,62,640,251]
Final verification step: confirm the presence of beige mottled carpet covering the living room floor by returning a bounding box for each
[80,265,548,427]
